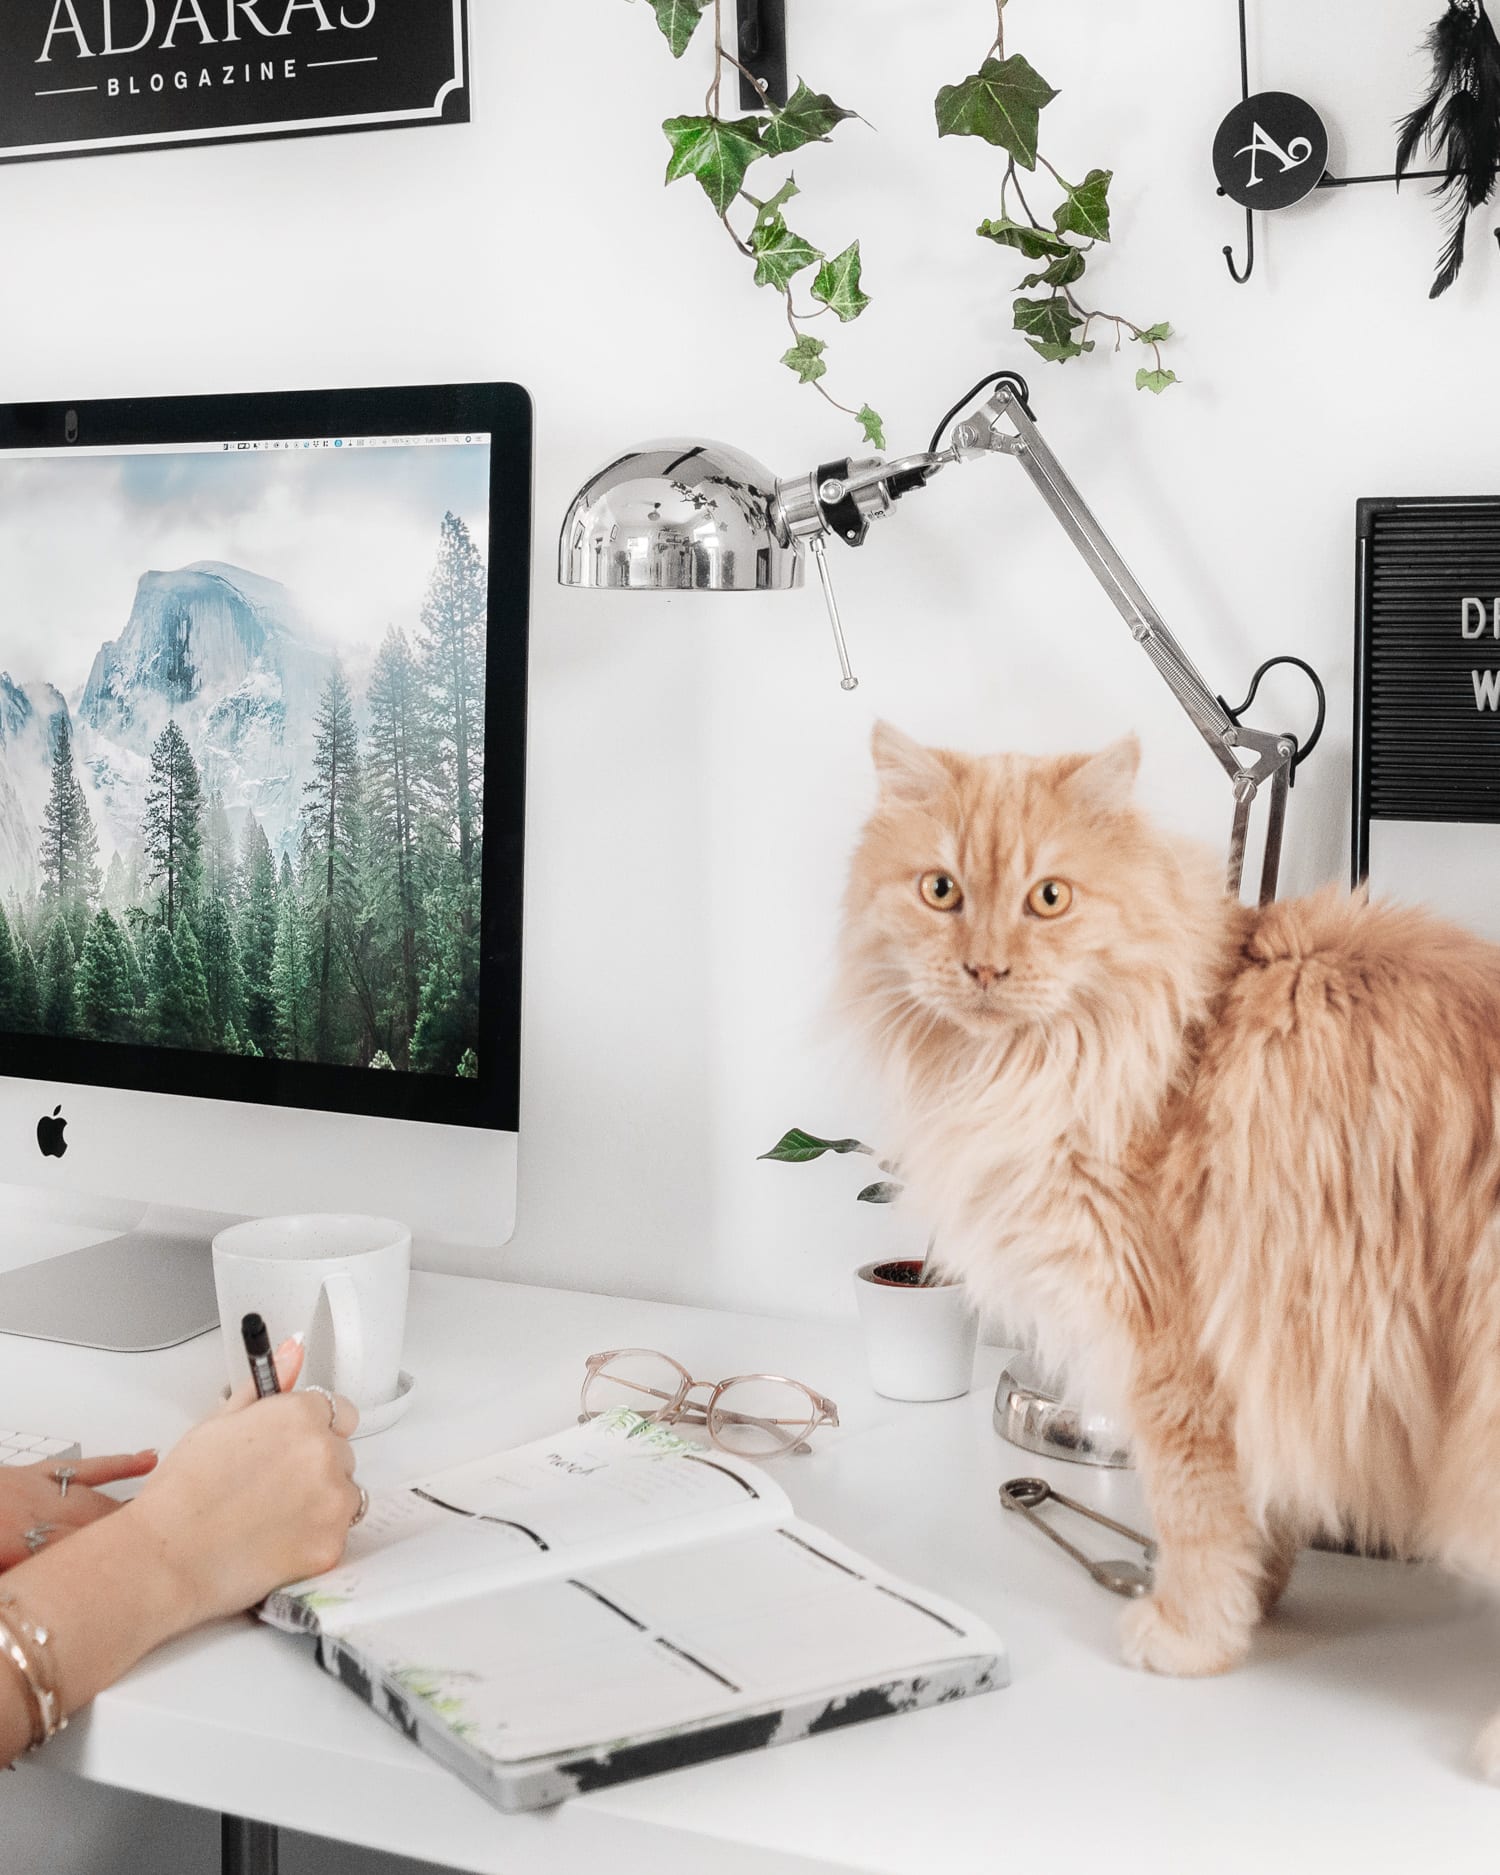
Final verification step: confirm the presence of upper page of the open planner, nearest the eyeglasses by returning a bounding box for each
[266,1412,791,1633]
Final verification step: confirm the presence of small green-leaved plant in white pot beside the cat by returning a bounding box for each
[761,1127,979,1401]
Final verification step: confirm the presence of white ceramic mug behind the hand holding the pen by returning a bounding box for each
[214,1211,411,1412]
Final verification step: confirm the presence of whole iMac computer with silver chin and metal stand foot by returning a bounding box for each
[0,384,533,1350]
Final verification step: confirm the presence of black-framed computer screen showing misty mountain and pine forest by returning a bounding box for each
[0,386,529,1129]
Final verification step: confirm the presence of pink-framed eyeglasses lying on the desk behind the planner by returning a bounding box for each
[578,1348,838,1459]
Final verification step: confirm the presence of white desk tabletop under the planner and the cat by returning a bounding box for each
[0,1277,1500,1875]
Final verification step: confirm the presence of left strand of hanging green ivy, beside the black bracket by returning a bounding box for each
[630,0,885,450]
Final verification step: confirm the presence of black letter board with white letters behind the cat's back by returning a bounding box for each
[1352,495,1500,885]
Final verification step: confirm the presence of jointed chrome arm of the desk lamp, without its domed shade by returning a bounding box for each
[776,384,1298,906]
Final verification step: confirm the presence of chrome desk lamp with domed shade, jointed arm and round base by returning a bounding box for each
[559,371,1324,1464]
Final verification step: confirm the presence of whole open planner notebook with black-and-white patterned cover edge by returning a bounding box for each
[261,1412,1007,1809]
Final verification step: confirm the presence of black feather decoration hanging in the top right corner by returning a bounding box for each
[1395,0,1500,300]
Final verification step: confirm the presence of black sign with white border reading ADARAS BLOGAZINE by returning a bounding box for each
[0,0,469,163]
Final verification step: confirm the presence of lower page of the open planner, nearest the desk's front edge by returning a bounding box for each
[333,1519,1001,1763]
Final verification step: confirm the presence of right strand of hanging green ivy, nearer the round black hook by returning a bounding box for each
[936,0,1178,394]
